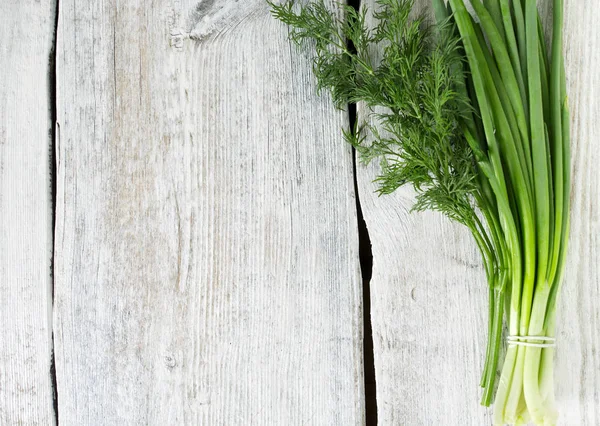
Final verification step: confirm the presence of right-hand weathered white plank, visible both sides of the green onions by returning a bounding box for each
[357,0,600,426]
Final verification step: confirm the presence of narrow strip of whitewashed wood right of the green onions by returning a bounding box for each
[555,0,600,426]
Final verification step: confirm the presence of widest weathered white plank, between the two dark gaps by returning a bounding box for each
[55,0,364,426]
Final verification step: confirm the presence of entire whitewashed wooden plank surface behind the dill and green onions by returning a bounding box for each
[0,0,600,426]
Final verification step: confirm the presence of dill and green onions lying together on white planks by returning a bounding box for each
[271,0,570,425]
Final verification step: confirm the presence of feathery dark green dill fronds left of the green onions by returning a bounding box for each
[271,0,478,228]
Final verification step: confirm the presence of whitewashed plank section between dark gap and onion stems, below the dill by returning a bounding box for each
[359,182,490,426]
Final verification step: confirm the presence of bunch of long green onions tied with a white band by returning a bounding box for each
[448,0,570,425]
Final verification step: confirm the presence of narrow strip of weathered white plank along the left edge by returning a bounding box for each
[0,0,55,425]
